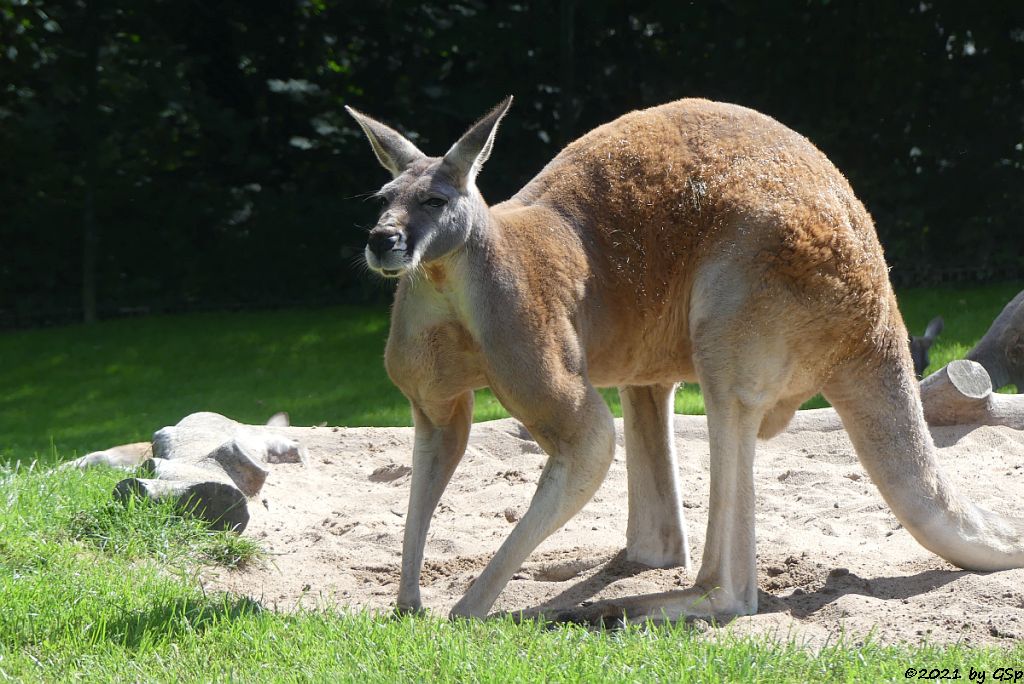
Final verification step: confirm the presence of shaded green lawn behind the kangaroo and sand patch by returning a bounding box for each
[0,284,1024,462]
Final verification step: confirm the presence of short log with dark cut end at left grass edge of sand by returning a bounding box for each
[114,477,249,533]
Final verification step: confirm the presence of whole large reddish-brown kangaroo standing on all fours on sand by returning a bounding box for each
[349,98,1024,621]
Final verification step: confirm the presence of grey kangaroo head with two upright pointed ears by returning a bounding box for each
[345,97,512,277]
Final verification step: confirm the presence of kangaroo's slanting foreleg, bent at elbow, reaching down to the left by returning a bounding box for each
[452,387,615,617]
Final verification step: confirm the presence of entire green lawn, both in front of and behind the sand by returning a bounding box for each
[0,285,1024,682]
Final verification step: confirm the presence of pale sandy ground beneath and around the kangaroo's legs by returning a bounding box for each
[206,416,1024,645]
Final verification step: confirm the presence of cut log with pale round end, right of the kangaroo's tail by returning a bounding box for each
[921,359,1024,430]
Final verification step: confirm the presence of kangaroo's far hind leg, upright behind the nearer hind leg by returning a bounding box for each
[618,385,690,569]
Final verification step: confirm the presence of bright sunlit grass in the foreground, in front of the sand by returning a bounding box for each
[0,462,1024,682]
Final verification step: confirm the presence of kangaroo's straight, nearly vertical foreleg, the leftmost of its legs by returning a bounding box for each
[397,391,473,611]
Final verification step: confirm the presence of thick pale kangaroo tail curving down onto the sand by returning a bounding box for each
[824,334,1024,570]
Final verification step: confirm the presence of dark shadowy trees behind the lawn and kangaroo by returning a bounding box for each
[0,0,1024,326]
